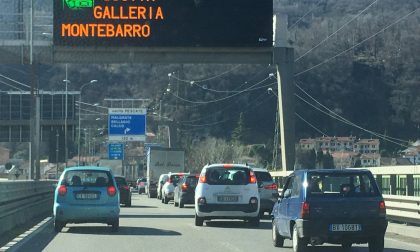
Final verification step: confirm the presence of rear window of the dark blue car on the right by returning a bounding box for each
[307,173,379,197]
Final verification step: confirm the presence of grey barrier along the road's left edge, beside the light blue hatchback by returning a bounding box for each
[0,180,57,235]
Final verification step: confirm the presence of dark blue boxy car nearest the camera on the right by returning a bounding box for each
[272,169,388,252]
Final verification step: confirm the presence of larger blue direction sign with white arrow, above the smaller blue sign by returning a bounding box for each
[108,108,146,141]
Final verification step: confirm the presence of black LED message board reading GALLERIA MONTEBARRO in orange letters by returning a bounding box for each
[54,0,273,47]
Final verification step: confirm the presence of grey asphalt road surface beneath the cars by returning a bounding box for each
[13,194,420,252]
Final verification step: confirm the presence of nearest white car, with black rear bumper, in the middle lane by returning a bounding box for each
[195,164,260,226]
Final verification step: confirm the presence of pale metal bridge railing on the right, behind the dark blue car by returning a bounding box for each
[270,165,420,225]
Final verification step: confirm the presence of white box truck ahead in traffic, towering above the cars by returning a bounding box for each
[145,147,185,198]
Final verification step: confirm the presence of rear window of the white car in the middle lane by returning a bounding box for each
[206,167,249,185]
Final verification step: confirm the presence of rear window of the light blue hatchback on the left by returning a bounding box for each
[61,170,112,187]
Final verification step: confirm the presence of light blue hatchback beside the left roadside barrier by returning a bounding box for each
[53,166,120,232]
